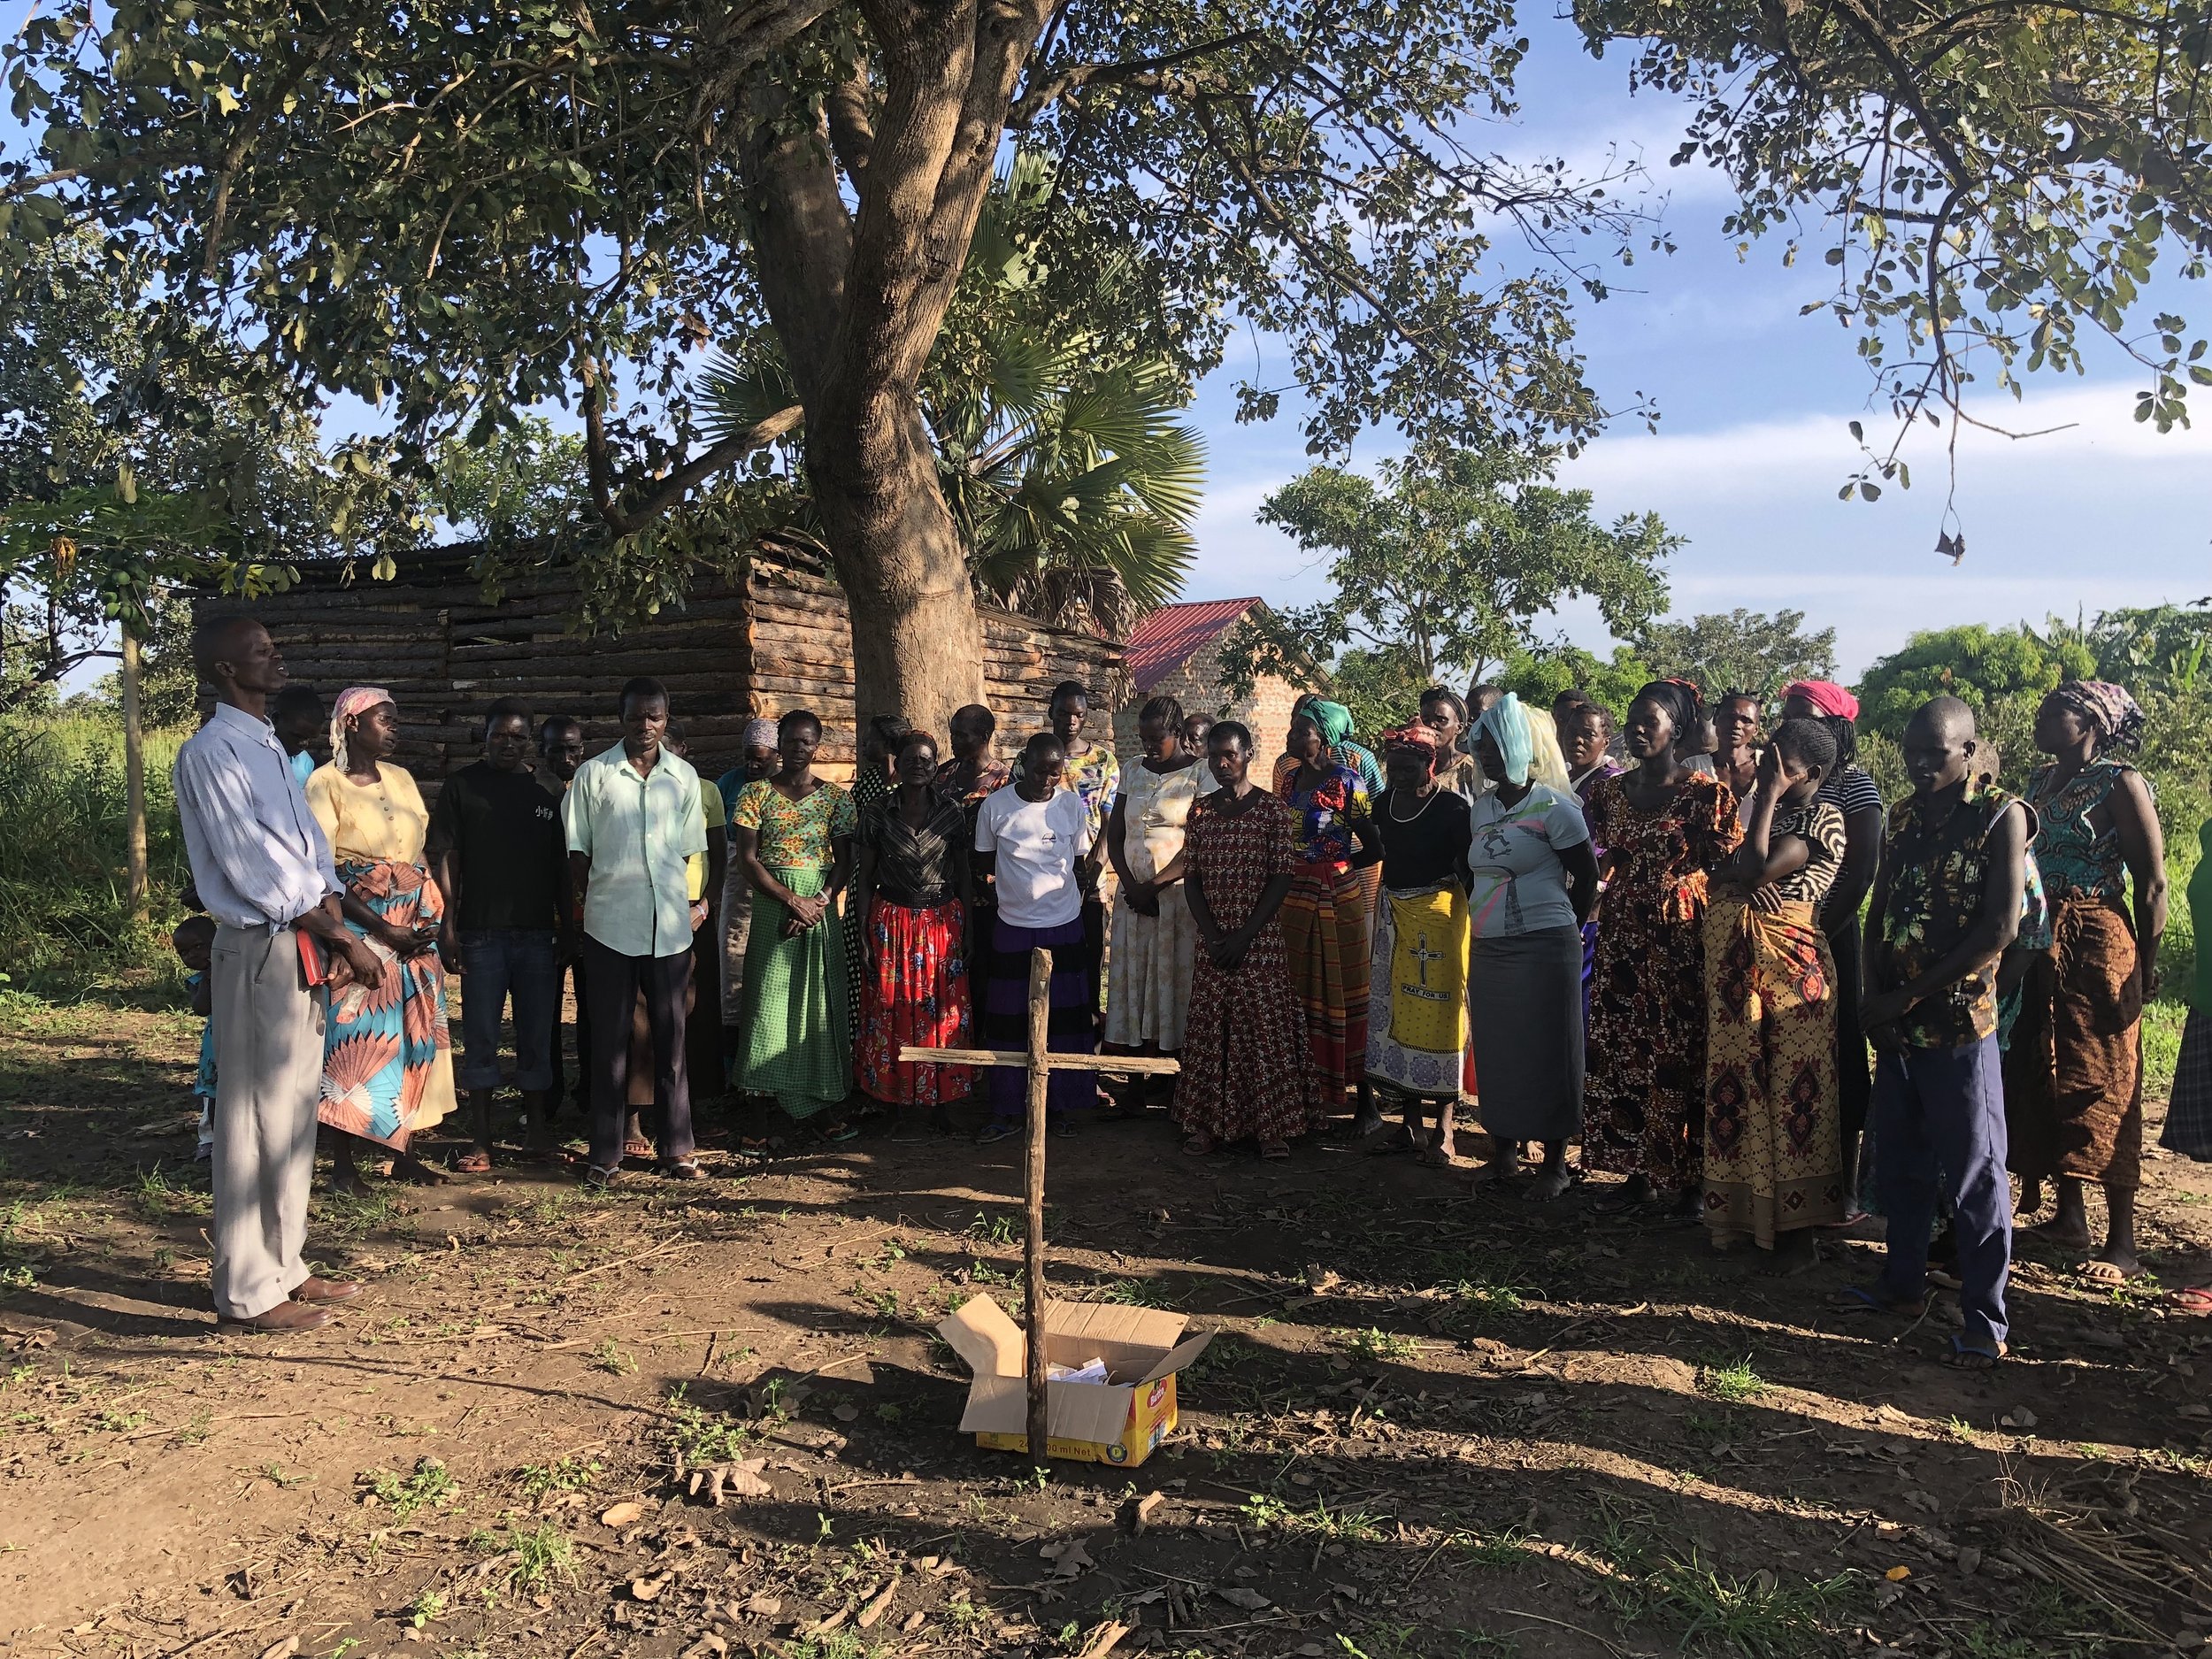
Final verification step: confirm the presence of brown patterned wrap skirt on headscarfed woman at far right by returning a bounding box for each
[2004,898,2144,1188]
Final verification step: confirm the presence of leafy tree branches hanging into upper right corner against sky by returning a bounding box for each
[1575,0,2212,518]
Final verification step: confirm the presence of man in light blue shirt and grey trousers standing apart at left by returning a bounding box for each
[175,618,385,1332]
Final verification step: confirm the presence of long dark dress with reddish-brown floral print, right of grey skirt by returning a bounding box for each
[1582,772,1743,1190]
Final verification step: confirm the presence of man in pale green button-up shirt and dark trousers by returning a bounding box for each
[560,680,706,1186]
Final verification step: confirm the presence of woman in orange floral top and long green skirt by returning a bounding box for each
[730,708,854,1141]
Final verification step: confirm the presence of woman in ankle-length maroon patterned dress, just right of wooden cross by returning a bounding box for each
[1164,721,1321,1157]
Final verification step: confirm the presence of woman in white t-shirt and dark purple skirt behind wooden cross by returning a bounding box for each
[972,733,1100,1144]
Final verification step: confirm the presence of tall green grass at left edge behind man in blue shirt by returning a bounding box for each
[0,712,190,995]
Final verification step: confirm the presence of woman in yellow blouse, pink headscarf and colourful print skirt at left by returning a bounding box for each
[308,686,454,1193]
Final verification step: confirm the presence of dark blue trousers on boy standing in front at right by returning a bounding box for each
[1871,1038,2013,1345]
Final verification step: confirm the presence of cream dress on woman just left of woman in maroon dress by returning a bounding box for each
[1106,761,1212,1056]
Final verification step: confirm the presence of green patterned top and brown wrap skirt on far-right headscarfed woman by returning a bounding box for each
[2004,759,2144,1188]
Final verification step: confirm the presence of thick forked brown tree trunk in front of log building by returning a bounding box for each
[746,0,1048,741]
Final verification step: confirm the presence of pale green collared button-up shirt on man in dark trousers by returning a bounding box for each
[560,743,706,956]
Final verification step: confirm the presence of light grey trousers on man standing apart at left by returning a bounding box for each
[208,927,323,1318]
